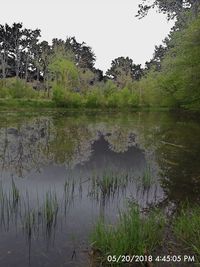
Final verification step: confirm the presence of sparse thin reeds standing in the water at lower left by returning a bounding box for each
[0,179,59,238]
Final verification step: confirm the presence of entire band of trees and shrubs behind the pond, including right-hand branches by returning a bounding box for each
[0,0,200,110]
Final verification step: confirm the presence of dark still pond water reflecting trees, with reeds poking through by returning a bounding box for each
[0,111,200,267]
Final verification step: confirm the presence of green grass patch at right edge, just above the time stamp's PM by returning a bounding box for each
[173,205,200,263]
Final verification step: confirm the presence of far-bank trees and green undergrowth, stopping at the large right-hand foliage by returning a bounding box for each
[0,23,143,107]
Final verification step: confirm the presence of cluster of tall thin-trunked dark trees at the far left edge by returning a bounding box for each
[0,23,40,80]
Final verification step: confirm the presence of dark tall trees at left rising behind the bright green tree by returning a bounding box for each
[0,23,102,86]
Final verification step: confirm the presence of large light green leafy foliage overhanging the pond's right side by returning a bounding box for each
[140,15,200,109]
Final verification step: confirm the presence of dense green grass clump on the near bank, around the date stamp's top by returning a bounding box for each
[91,205,165,261]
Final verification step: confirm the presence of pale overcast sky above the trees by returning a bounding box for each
[0,0,173,71]
